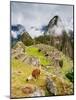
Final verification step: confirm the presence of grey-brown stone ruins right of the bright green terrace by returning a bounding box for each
[37,44,63,67]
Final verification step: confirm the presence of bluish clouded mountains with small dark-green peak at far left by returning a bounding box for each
[11,24,32,46]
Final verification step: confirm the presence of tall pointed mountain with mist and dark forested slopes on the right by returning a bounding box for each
[35,16,74,59]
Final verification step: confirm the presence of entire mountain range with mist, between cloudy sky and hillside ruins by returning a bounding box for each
[11,15,74,58]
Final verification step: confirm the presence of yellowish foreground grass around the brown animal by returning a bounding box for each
[11,59,73,97]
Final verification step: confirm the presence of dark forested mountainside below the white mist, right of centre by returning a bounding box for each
[35,31,74,59]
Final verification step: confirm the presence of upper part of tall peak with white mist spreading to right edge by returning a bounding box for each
[41,15,73,36]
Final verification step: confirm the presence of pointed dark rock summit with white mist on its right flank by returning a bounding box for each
[47,15,65,36]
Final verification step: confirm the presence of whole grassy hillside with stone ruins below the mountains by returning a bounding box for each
[11,42,73,98]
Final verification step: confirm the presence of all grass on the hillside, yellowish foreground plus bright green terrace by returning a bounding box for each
[11,46,73,97]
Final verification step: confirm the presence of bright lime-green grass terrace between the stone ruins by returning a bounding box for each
[26,46,50,65]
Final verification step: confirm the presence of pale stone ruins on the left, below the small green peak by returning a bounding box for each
[11,41,40,67]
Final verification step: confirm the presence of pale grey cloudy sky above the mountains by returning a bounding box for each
[11,2,73,37]
